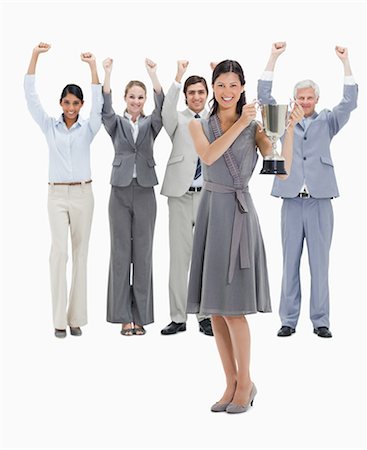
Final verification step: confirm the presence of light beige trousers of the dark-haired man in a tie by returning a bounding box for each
[168,192,208,323]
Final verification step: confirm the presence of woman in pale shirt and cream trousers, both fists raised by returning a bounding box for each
[24,42,103,338]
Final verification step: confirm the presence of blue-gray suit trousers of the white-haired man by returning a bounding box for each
[279,197,334,328]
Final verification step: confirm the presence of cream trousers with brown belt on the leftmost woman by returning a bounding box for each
[48,183,94,330]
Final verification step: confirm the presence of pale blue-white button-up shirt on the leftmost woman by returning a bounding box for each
[24,74,103,183]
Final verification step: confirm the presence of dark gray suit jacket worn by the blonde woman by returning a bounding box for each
[102,91,164,187]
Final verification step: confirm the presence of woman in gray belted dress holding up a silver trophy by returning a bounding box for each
[187,60,303,413]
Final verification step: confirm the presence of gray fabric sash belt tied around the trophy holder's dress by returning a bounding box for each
[203,181,250,284]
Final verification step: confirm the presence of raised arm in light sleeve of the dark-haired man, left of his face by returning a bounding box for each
[162,60,189,139]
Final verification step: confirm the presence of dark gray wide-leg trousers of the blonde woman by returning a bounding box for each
[107,178,156,325]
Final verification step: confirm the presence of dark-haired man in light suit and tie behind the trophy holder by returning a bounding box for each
[161,61,213,336]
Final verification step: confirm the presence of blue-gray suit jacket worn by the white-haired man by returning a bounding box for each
[258,80,358,198]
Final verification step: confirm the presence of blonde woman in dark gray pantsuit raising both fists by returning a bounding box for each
[102,58,164,336]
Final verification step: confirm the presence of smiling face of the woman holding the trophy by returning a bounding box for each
[213,72,244,109]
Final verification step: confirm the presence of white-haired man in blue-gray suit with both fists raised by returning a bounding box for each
[258,42,358,338]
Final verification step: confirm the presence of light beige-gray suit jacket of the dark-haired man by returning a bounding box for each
[161,83,208,197]
